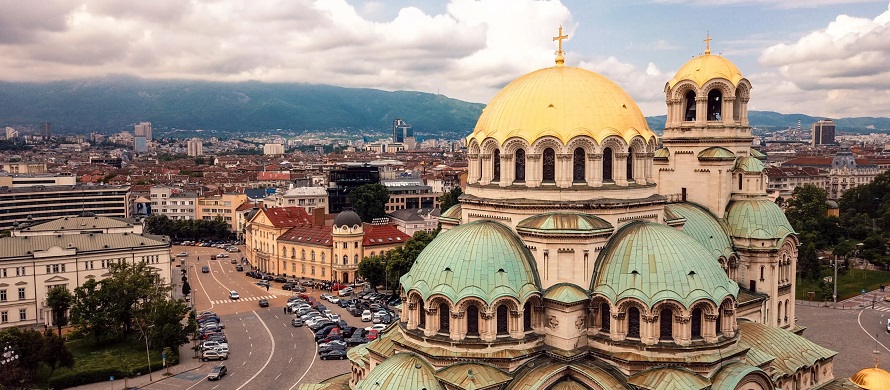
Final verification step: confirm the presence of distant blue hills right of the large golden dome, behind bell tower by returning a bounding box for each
[646,111,890,133]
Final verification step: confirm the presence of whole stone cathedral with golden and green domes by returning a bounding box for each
[303,33,857,390]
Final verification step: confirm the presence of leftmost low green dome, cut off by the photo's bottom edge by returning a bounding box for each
[355,352,445,390]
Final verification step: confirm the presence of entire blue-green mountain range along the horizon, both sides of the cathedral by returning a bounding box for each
[0,76,890,139]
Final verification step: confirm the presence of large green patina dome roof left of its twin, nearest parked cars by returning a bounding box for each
[401,220,541,303]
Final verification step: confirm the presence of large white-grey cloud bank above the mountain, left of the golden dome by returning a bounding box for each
[0,0,572,102]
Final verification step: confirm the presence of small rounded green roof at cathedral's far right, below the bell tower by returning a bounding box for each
[726,199,794,244]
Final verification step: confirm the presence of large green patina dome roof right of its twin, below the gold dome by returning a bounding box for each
[591,221,739,307]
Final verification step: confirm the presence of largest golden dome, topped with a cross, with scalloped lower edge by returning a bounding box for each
[467,64,655,145]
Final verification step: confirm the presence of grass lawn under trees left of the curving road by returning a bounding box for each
[36,334,175,388]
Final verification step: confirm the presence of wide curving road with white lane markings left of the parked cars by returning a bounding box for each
[146,246,350,390]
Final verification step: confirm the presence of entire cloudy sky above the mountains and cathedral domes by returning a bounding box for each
[0,0,890,119]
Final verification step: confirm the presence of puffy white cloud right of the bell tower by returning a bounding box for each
[752,3,890,116]
